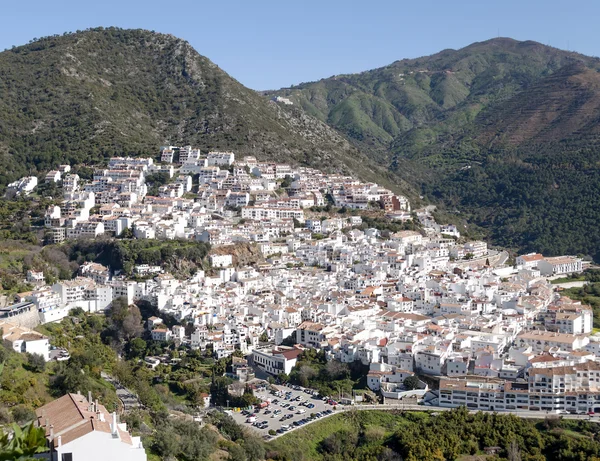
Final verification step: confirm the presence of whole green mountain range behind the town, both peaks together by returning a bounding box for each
[5,28,600,261]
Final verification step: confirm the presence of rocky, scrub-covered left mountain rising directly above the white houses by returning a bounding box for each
[0,28,404,191]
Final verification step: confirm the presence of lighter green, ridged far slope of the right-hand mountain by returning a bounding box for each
[268,38,600,150]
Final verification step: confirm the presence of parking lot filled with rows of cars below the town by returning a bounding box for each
[232,380,342,438]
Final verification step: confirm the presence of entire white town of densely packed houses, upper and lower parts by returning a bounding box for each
[0,146,600,411]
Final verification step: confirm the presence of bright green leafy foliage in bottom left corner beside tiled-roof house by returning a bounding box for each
[0,422,48,461]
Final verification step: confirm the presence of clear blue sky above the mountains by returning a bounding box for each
[0,0,600,90]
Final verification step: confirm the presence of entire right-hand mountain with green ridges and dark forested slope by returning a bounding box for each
[265,38,600,259]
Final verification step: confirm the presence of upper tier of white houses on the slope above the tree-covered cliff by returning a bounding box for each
[39,146,411,245]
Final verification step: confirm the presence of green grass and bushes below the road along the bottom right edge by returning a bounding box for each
[267,407,600,461]
